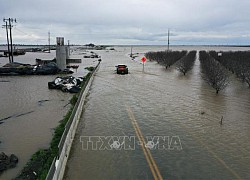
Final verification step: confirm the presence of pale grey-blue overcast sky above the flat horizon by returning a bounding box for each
[0,0,250,45]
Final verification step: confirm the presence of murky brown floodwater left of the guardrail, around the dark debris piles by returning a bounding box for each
[0,47,96,179]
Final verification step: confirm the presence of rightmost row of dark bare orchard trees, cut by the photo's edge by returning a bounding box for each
[209,51,250,87]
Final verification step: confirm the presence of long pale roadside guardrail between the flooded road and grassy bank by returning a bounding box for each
[46,61,100,180]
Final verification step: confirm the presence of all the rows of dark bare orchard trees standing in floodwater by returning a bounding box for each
[145,51,250,94]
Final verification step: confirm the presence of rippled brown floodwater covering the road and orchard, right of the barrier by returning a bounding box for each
[64,46,250,180]
